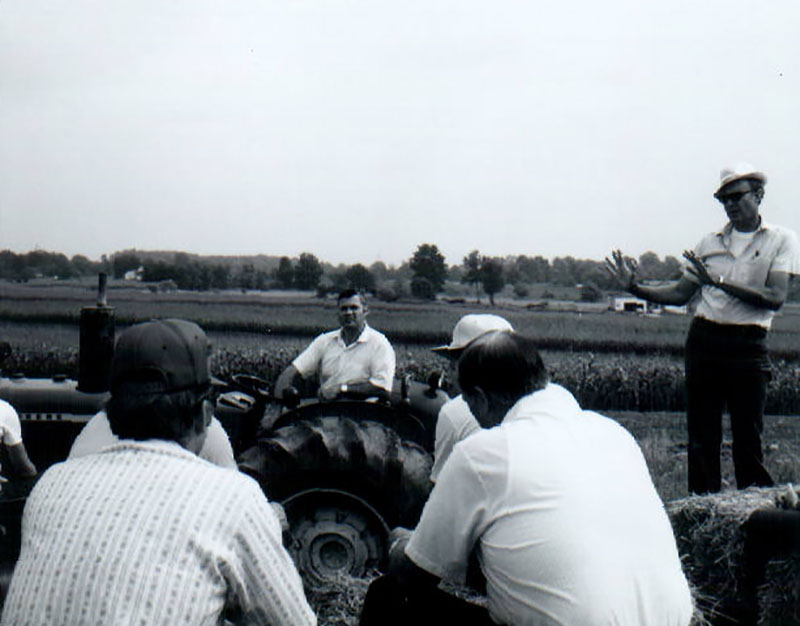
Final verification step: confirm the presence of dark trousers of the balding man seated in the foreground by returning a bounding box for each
[359,574,496,626]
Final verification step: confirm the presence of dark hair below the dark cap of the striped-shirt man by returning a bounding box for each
[106,372,211,442]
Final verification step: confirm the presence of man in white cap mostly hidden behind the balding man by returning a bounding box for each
[431,313,514,482]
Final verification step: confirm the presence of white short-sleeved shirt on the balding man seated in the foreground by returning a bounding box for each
[406,385,692,626]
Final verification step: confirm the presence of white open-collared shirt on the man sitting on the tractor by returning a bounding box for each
[292,325,395,392]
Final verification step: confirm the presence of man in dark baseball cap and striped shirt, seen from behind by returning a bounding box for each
[2,319,316,626]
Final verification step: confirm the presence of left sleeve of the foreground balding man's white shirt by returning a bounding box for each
[406,438,489,583]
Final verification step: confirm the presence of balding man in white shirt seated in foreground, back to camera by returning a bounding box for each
[361,332,692,626]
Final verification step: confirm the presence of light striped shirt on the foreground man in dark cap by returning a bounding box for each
[2,440,316,626]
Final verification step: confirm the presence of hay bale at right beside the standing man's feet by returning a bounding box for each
[667,487,800,624]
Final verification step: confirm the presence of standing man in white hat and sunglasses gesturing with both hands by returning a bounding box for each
[606,163,800,493]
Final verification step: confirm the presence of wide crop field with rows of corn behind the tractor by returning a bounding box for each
[0,283,800,626]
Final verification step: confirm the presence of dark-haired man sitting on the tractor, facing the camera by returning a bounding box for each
[275,289,395,400]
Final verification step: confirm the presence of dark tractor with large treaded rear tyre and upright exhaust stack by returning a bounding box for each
[0,274,447,582]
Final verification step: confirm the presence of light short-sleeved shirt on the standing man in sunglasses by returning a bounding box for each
[684,220,800,328]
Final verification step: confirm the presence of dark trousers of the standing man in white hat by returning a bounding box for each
[686,318,773,493]
